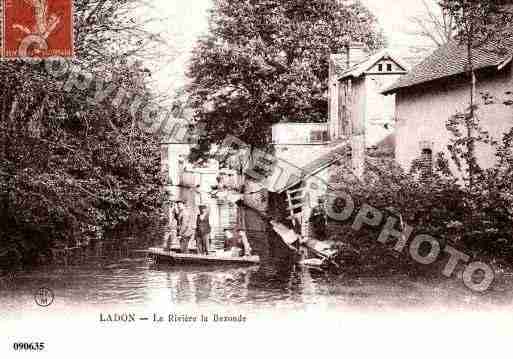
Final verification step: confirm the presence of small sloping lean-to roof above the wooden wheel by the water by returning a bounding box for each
[280,140,351,192]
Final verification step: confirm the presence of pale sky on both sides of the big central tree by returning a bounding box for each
[143,0,435,94]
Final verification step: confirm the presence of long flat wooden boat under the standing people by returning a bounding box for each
[147,248,260,266]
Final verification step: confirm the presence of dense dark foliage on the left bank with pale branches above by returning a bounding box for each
[0,0,161,267]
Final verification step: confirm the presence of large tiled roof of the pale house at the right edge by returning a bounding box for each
[382,41,513,95]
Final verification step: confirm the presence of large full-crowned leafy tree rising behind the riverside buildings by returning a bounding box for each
[189,0,384,160]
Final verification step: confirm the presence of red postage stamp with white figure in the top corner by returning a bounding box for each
[0,0,74,58]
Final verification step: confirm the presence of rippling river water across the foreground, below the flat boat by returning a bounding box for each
[0,253,513,313]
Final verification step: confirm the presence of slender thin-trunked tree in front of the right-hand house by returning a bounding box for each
[432,0,513,239]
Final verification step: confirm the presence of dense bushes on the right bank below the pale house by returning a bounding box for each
[324,99,513,273]
